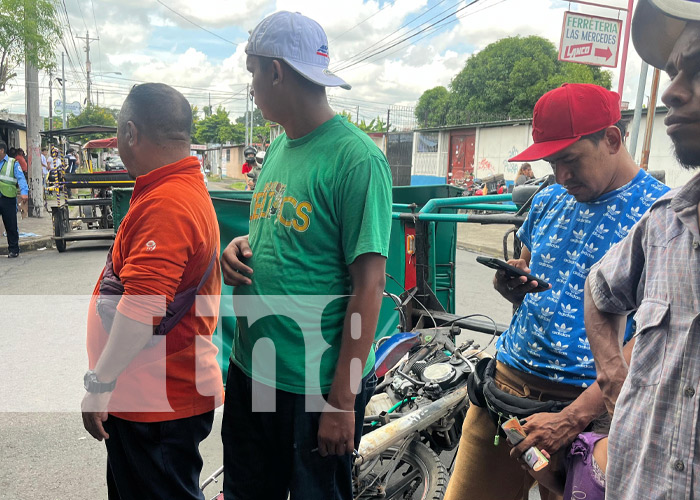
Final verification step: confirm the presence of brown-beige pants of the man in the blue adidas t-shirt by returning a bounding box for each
[445,362,582,500]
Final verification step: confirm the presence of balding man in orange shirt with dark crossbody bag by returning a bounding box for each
[82,83,223,499]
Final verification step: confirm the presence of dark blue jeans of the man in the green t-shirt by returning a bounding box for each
[221,363,377,500]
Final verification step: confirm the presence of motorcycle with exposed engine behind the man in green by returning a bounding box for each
[201,289,502,500]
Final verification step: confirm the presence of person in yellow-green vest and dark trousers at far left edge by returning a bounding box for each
[0,141,29,259]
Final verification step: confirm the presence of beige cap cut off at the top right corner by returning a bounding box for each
[632,0,700,69]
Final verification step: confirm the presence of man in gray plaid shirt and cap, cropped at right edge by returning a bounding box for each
[585,0,700,500]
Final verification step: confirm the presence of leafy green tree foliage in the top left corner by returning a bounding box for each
[0,0,61,92]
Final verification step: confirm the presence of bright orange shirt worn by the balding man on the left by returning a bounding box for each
[87,157,223,422]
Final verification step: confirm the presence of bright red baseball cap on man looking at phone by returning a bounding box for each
[508,83,622,161]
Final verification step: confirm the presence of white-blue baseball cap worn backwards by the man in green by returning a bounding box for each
[245,11,350,90]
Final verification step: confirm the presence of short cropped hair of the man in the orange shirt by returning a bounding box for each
[119,83,192,143]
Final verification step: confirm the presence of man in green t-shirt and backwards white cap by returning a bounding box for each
[222,12,391,500]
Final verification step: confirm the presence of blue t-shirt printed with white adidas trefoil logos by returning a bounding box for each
[497,170,669,387]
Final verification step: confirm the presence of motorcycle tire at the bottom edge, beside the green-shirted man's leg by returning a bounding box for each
[360,441,449,500]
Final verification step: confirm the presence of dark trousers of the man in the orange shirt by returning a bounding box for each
[104,410,214,500]
